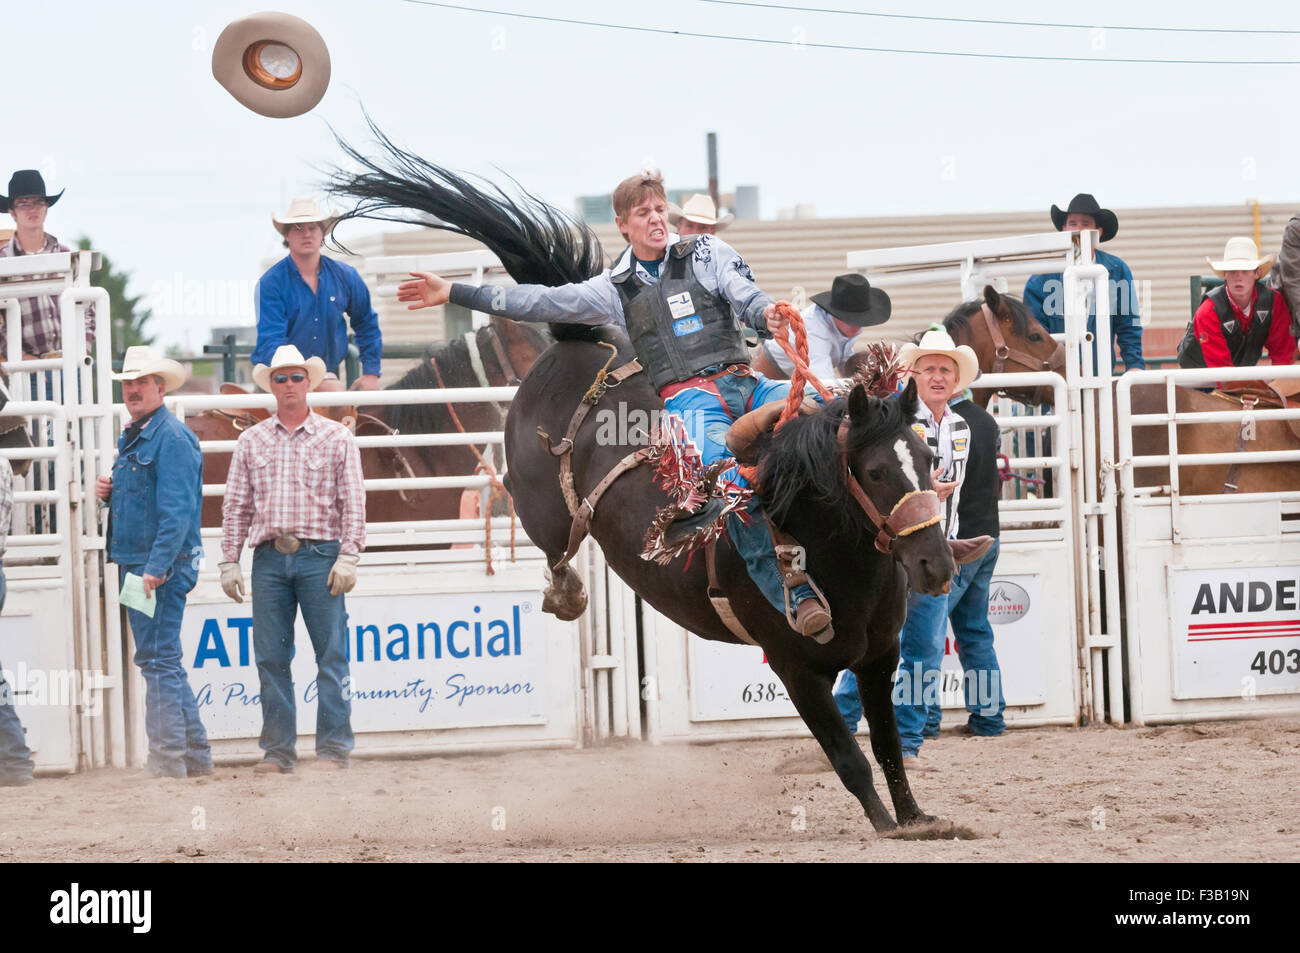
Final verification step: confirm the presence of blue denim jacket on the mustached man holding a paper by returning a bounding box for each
[108,407,203,576]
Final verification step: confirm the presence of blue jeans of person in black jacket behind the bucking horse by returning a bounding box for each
[935,542,1006,735]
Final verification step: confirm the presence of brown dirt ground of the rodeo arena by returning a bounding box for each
[0,716,1300,863]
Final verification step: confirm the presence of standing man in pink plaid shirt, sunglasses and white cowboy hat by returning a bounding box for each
[221,345,365,774]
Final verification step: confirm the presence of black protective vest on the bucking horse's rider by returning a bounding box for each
[611,237,749,393]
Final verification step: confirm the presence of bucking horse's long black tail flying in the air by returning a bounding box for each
[326,116,605,286]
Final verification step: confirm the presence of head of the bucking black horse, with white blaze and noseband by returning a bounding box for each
[839,380,957,595]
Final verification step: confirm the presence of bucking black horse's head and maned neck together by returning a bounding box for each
[757,382,957,595]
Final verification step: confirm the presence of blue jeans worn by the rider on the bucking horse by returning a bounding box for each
[666,373,813,614]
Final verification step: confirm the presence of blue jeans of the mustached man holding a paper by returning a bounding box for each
[121,559,212,777]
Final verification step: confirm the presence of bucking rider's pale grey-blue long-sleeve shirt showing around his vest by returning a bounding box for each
[451,235,772,338]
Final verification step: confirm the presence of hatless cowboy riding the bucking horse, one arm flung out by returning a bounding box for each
[398,172,831,642]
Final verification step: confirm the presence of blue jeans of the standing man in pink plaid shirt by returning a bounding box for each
[252,542,354,768]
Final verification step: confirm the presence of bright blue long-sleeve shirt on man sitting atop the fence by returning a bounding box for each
[251,255,384,374]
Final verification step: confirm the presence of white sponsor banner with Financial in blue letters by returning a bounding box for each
[181,590,547,738]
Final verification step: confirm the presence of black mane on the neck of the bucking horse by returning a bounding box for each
[758,398,910,534]
